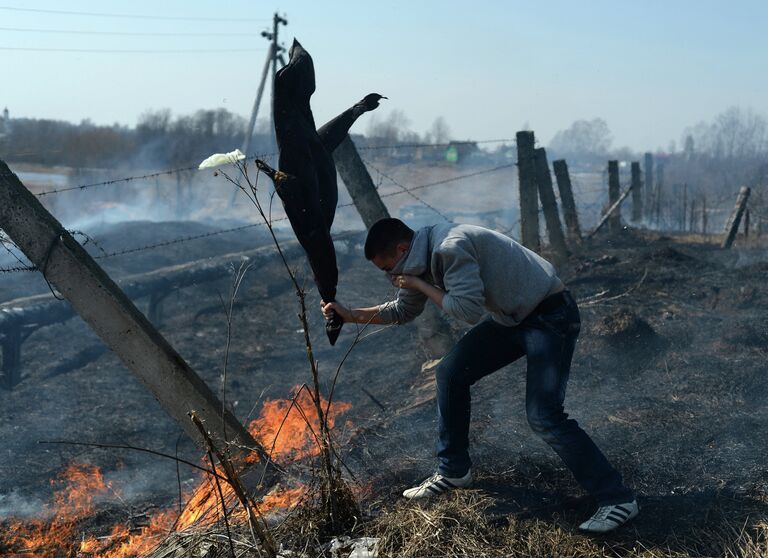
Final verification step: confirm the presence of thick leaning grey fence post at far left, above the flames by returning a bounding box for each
[0,161,278,487]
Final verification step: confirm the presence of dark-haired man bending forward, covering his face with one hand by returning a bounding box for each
[322,219,639,532]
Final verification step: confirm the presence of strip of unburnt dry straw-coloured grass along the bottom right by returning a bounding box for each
[366,491,768,558]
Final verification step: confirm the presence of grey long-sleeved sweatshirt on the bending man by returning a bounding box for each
[378,223,563,326]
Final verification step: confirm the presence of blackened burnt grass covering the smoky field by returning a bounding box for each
[0,223,768,556]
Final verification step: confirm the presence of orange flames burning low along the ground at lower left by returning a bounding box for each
[0,388,351,558]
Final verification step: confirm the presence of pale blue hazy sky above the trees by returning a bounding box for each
[0,0,768,151]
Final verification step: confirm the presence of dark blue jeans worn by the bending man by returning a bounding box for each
[436,291,633,505]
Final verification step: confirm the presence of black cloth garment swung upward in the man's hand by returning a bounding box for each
[257,39,383,345]
